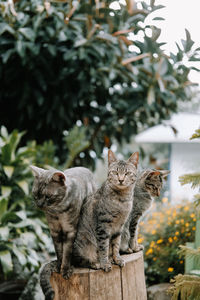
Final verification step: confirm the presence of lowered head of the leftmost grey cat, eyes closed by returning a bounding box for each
[31,166,67,210]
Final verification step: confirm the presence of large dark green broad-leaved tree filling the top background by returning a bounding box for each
[0,0,200,164]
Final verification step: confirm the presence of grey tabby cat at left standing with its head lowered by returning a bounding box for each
[31,166,96,278]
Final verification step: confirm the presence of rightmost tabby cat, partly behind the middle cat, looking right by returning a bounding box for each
[120,169,170,253]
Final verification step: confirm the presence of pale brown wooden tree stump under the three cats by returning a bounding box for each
[51,251,147,300]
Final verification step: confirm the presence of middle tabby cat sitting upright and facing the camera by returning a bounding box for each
[73,150,139,272]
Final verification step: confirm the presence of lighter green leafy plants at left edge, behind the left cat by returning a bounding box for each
[0,126,87,281]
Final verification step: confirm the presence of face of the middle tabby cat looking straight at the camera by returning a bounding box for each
[108,150,139,190]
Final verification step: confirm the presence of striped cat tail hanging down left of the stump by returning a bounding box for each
[39,260,57,300]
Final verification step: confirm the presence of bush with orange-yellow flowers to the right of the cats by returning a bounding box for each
[138,198,196,285]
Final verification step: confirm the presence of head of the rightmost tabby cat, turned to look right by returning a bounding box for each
[144,170,170,197]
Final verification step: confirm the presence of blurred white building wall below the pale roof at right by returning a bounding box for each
[170,143,200,202]
